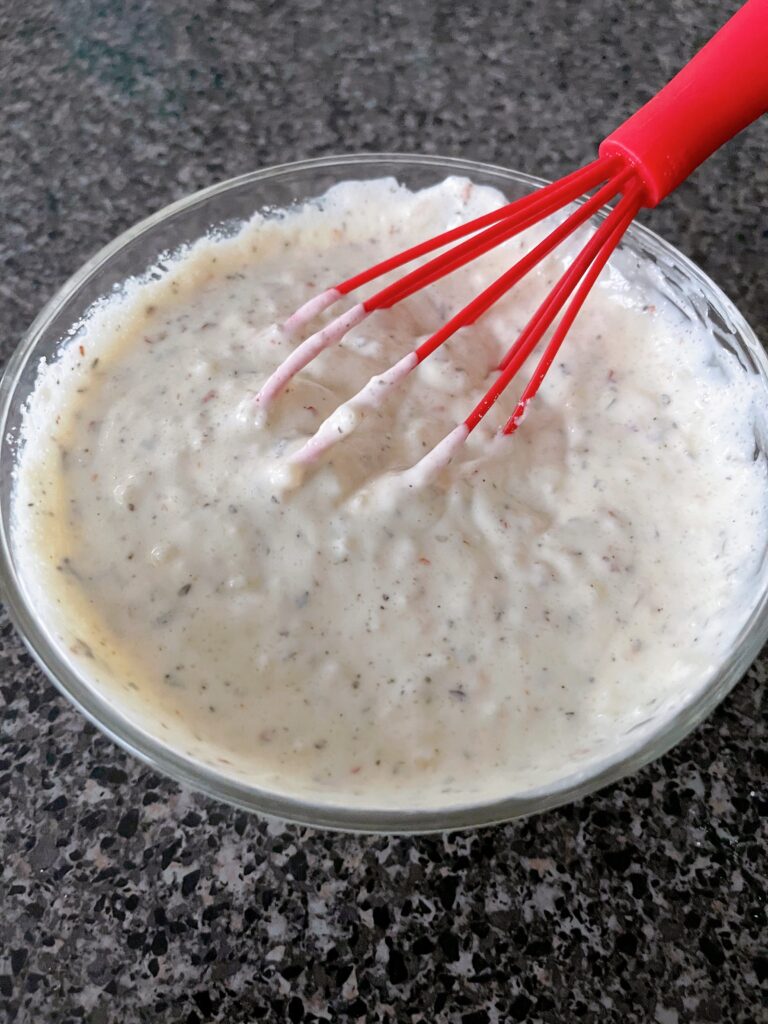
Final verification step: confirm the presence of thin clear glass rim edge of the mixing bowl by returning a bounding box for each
[0,153,768,835]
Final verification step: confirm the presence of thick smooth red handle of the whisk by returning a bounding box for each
[600,0,768,207]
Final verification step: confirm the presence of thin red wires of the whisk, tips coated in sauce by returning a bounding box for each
[256,156,644,485]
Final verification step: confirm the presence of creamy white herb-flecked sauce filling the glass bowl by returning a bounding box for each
[13,178,767,807]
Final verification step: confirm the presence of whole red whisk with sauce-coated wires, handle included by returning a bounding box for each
[256,0,768,475]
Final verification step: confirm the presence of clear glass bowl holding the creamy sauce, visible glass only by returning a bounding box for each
[0,154,768,833]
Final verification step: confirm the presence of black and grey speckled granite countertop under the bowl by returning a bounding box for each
[0,0,768,1024]
